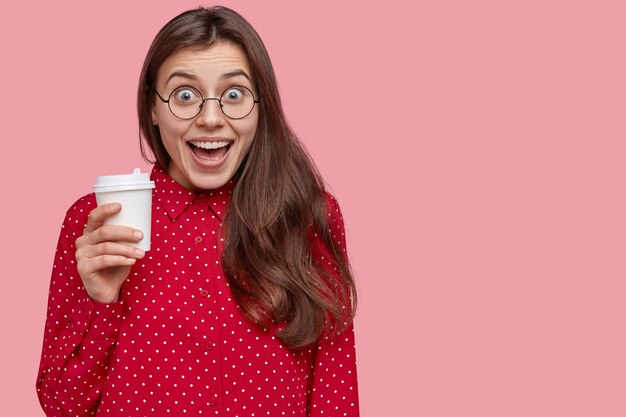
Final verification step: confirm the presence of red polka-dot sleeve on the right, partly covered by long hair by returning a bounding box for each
[307,195,359,417]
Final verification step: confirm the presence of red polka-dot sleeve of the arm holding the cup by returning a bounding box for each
[37,195,124,417]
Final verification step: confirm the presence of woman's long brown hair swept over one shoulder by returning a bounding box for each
[137,7,356,348]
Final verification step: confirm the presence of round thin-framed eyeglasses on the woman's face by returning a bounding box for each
[154,85,259,120]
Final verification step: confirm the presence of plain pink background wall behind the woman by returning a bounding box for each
[0,0,626,417]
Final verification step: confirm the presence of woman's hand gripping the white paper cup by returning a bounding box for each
[76,203,145,303]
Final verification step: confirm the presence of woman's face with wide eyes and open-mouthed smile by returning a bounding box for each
[152,42,259,193]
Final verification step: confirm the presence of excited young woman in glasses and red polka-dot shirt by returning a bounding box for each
[37,7,359,417]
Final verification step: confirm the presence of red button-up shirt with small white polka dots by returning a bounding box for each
[37,167,359,417]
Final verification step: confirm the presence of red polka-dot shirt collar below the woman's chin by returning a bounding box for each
[150,164,235,220]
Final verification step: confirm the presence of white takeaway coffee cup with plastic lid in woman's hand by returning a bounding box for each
[93,168,154,251]
